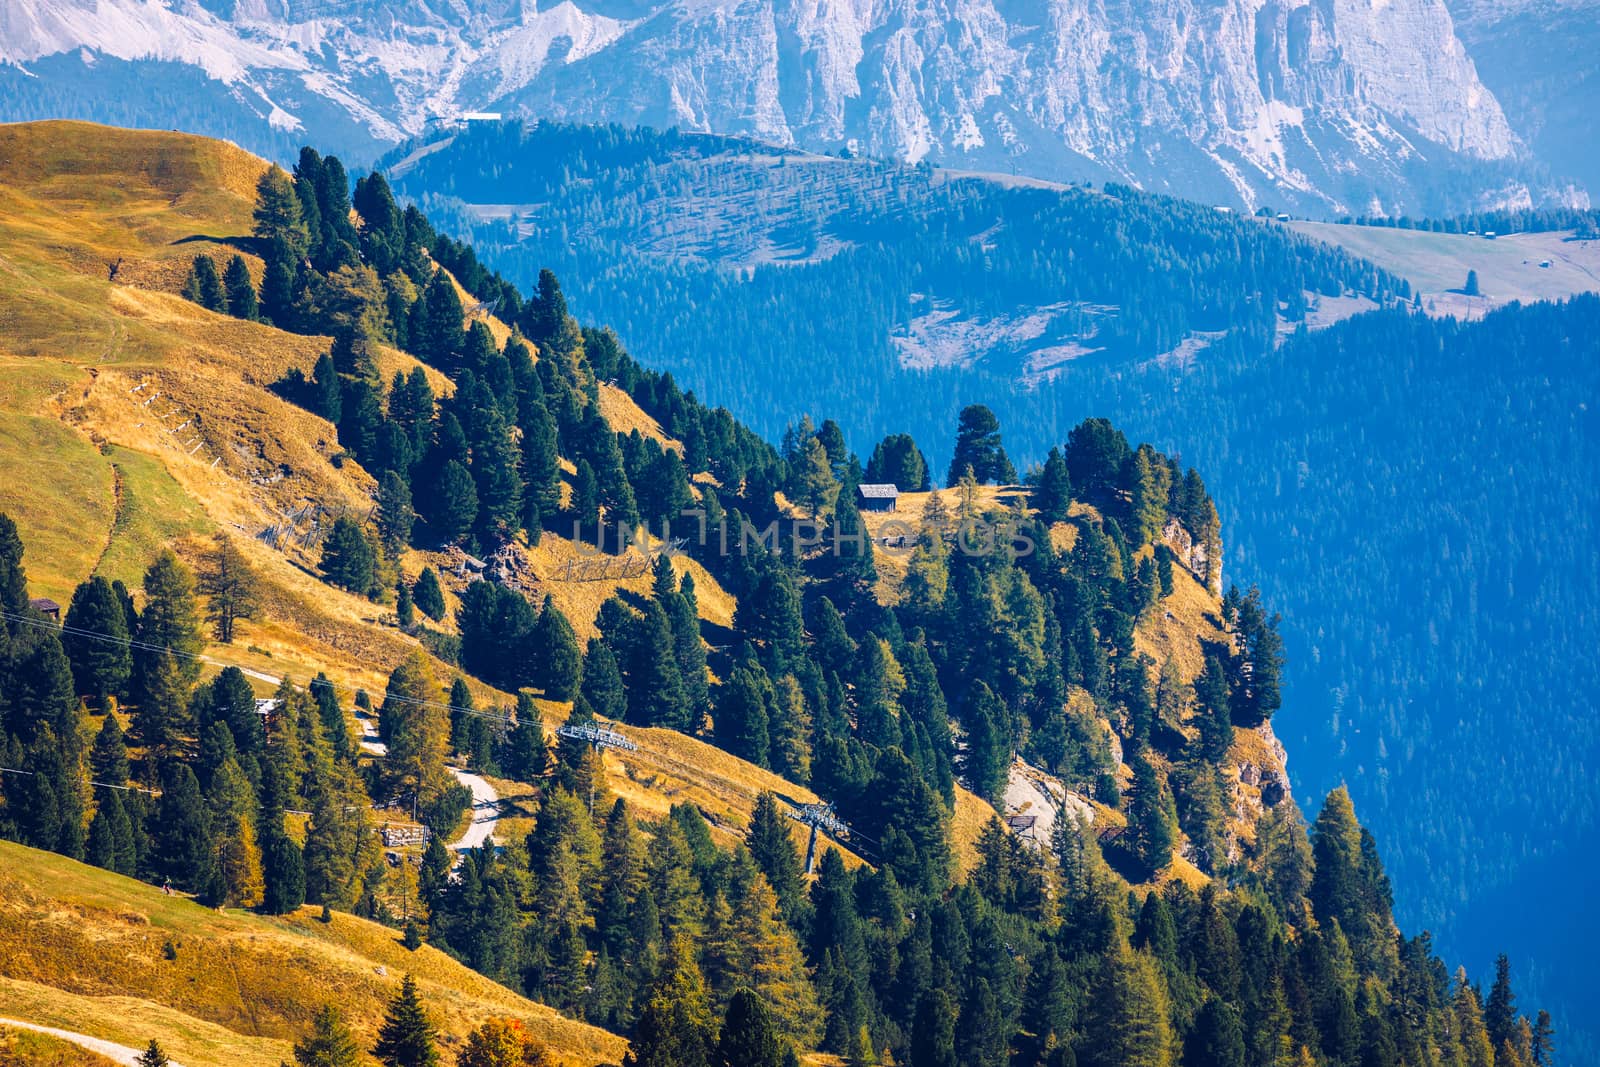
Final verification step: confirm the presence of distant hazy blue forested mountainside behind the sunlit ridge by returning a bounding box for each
[380,119,1600,1062]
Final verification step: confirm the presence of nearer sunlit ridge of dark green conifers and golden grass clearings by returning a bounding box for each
[0,125,1552,1067]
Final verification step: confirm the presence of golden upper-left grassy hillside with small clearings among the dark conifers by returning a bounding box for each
[0,122,883,902]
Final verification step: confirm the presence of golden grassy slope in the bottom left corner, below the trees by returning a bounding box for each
[0,843,622,1067]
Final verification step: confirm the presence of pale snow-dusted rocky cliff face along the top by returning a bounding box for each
[0,0,1574,211]
